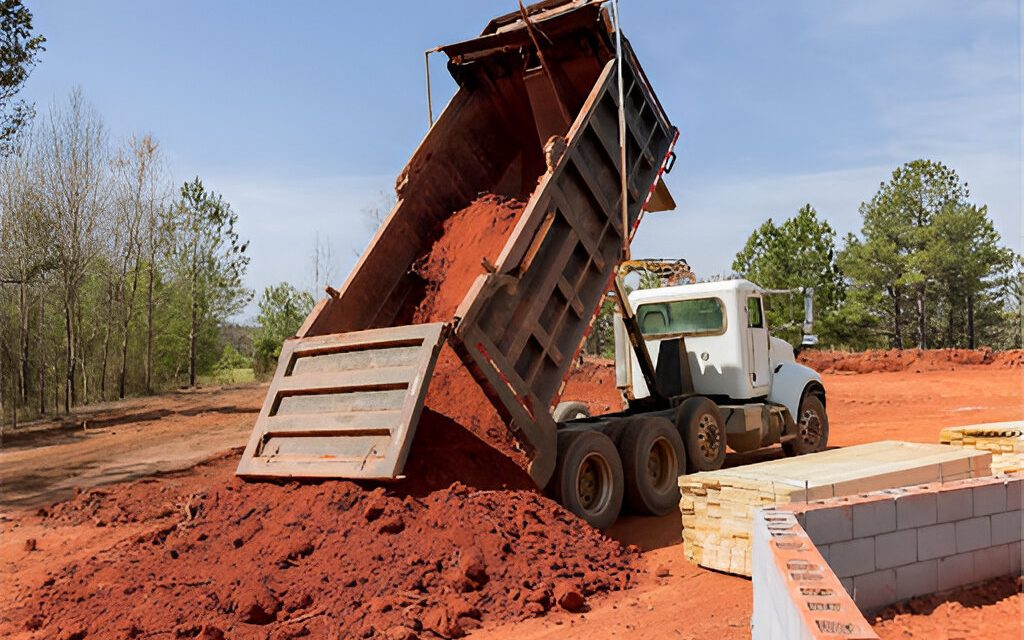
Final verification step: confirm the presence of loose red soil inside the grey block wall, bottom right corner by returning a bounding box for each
[871,577,1024,640]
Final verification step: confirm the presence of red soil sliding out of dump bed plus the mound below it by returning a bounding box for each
[0,196,636,640]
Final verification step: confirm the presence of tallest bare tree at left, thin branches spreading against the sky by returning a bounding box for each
[34,89,109,412]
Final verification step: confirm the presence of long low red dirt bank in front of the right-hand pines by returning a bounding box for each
[798,348,1024,374]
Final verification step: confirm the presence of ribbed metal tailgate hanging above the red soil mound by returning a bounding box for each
[237,323,449,479]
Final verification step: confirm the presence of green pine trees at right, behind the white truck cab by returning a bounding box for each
[732,160,1022,349]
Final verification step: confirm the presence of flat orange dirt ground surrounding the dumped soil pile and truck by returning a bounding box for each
[0,356,1024,640]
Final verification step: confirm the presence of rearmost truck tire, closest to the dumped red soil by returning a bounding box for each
[551,431,623,529]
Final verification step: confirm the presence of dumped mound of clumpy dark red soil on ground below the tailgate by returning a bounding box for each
[6,464,634,639]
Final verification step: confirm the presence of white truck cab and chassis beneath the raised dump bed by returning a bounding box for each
[554,276,828,517]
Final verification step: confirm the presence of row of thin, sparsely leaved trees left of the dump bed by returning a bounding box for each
[0,91,252,421]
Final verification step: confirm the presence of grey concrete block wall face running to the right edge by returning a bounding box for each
[779,474,1024,612]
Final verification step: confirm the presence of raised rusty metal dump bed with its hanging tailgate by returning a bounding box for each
[238,0,677,486]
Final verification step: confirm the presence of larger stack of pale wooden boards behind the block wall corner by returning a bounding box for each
[679,440,991,575]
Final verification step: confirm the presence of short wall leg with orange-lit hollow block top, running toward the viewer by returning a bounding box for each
[751,507,878,640]
